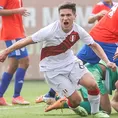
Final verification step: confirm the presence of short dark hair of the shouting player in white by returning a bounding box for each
[58,2,76,14]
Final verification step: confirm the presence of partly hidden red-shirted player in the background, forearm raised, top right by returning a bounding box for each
[88,0,116,24]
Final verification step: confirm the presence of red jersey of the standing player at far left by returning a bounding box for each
[0,0,25,40]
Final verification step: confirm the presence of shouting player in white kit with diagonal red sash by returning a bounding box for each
[0,2,116,117]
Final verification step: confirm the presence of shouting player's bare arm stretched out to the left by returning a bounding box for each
[0,37,34,62]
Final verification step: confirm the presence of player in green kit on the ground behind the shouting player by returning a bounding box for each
[45,61,118,114]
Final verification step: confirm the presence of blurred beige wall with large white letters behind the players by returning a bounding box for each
[0,0,118,80]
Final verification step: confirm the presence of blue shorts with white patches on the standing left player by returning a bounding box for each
[5,38,28,59]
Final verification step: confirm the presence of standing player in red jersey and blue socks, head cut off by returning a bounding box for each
[0,0,29,106]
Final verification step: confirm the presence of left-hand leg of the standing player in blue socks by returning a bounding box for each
[0,41,18,105]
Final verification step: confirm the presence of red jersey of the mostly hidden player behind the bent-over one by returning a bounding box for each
[92,2,115,21]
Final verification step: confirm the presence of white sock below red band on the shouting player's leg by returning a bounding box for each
[88,94,100,114]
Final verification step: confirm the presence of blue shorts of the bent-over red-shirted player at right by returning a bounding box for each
[77,41,118,66]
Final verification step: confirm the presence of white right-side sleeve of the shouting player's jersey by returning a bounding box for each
[79,26,95,45]
